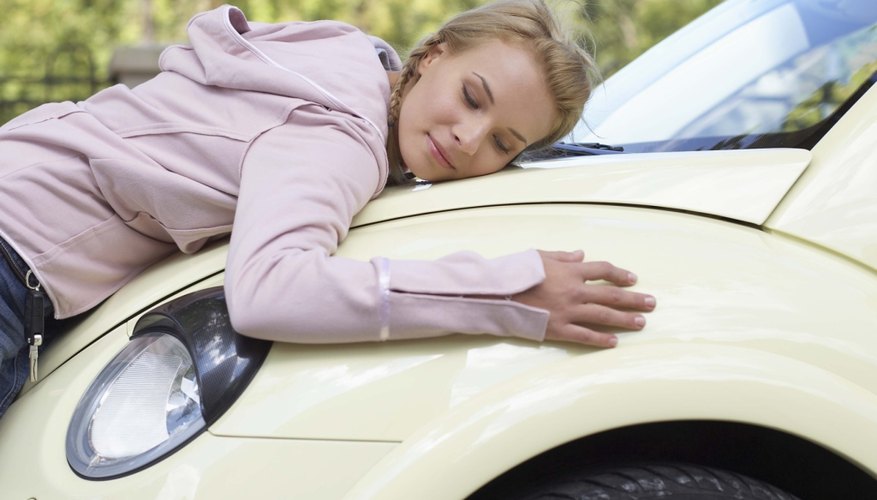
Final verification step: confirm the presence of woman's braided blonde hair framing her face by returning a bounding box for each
[387,0,595,183]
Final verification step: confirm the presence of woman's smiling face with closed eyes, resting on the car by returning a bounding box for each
[398,40,557,182]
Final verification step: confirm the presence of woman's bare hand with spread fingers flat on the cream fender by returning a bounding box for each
[512,250,655,347]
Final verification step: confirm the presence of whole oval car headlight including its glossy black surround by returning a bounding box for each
[67,288,271,479]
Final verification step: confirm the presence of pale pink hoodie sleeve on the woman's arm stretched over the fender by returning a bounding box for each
[225,106,548,343]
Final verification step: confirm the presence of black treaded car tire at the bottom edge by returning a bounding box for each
[523,463,797,500]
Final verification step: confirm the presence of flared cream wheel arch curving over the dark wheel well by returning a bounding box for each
[345,344,877,499]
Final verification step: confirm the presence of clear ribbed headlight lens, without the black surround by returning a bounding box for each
[67,333,205,478]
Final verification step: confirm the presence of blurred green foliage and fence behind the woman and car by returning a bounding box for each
[0,0,721,123]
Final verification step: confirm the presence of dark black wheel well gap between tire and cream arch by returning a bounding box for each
[469,421,877,500]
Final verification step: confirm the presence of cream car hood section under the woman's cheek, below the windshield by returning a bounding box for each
[353,149,811,226]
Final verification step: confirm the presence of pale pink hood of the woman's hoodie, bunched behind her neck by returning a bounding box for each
[159,5,401,140]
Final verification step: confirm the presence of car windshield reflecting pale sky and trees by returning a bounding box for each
[564,0,877,152]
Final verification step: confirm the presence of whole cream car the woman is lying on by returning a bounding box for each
[0,0,877,500]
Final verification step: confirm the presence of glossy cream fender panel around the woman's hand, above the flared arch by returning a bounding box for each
[213,205,877,441]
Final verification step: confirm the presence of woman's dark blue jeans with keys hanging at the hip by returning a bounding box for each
[0,238,54,417]
